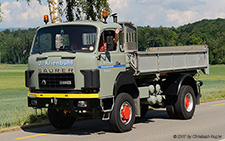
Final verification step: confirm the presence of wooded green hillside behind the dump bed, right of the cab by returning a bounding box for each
[138,19,225,64]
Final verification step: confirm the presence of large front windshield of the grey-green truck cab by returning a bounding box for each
[32,25,97,54]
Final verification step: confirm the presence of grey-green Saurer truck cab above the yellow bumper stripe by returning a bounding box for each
[26,21,126,98]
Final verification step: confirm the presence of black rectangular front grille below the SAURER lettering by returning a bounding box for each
[38,73,75,89]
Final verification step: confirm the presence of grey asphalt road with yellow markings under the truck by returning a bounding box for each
[0,100,225,141]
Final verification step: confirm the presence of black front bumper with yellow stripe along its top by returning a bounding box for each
[27,93,99,109]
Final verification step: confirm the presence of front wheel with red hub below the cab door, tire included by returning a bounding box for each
[109,93,135,132]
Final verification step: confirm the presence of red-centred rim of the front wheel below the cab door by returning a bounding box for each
[120,102,132,124]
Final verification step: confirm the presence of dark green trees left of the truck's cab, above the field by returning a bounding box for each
[0,28,36,64]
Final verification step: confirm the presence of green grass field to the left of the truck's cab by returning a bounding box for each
[0,64,49,130]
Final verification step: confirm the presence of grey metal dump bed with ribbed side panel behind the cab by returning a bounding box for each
[130,45,209,75]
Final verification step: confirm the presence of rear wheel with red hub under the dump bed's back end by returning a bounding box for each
[174,85,196,119]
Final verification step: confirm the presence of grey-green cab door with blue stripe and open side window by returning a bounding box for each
[98,30,126,97]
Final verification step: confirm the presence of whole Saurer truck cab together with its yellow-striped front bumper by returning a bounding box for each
[26,21,134,131]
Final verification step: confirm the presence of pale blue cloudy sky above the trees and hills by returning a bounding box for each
[0,0,225,28]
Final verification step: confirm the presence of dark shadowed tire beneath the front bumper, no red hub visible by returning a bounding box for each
[48,109,75,129]
